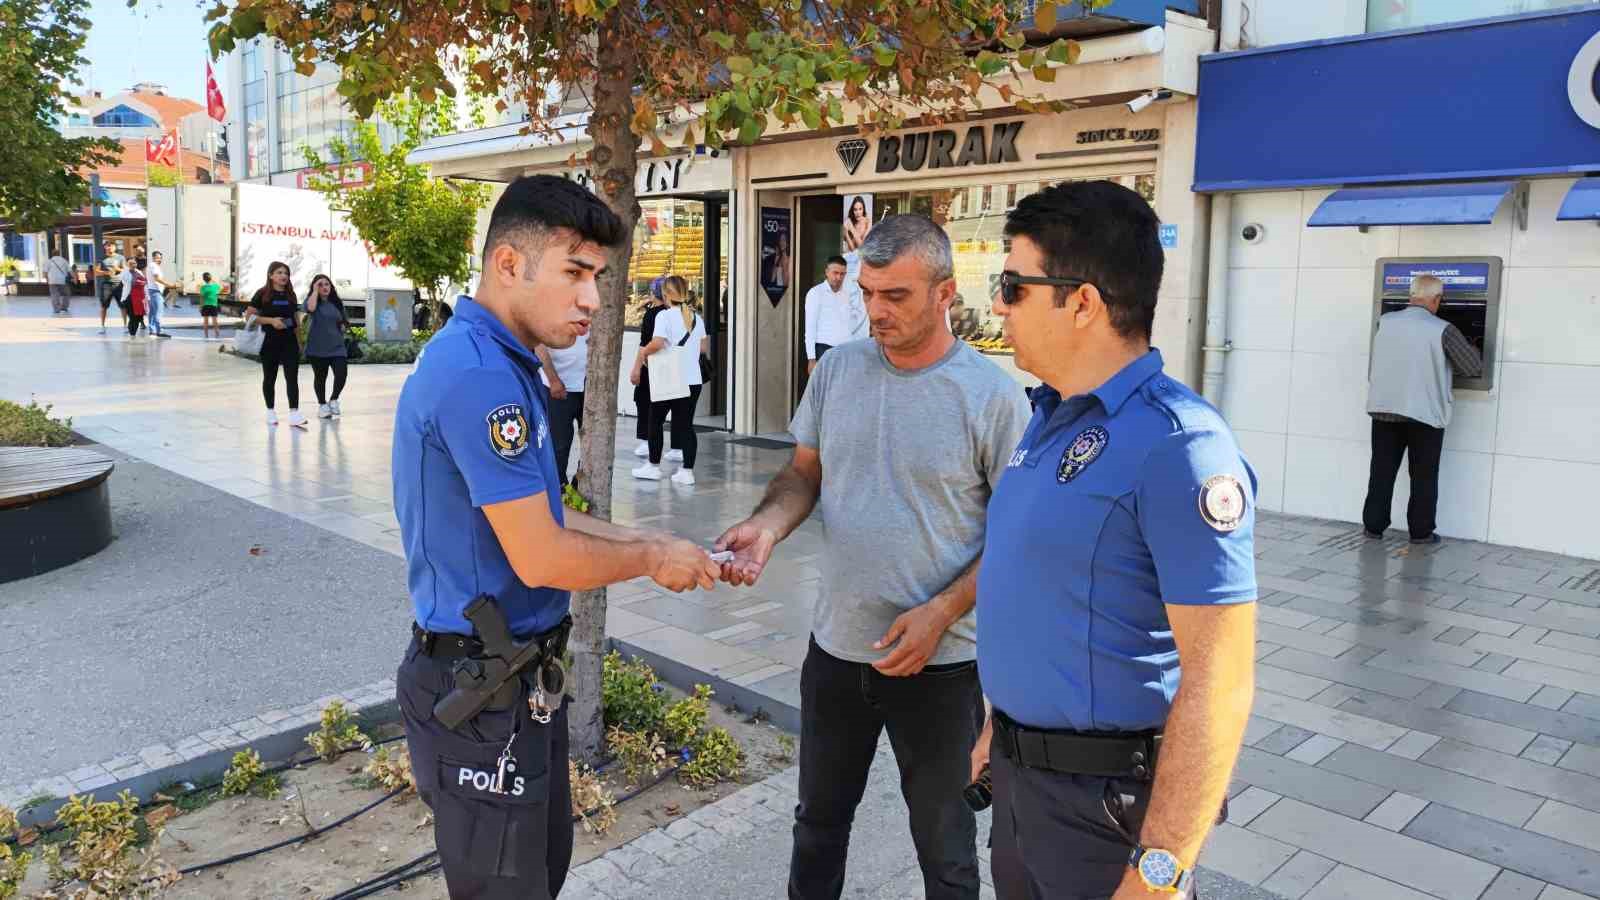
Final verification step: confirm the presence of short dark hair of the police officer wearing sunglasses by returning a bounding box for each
[1005,181,1166,340]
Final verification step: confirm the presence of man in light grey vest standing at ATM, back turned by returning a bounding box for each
[1362,275,1483,544]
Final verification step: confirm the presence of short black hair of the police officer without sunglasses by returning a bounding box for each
[483,175,629,264]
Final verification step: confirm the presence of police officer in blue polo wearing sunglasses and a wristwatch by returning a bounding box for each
[973,181,1256,900]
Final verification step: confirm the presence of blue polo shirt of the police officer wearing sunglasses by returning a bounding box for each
[978,349,1256,732]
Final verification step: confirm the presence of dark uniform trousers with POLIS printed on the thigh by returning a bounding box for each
[395,639,573,900]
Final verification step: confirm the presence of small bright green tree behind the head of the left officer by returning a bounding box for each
[304,98,490,322]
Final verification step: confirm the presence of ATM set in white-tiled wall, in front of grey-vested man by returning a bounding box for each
[1373,256,1501,391]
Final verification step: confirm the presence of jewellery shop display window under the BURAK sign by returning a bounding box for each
[876,173,1155,354]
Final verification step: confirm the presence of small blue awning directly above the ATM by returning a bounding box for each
[1306,181,1512,227]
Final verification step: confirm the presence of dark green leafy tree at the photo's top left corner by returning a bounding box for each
[0,0,120,232]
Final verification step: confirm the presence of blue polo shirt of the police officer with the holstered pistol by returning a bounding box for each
[392,296,570,636]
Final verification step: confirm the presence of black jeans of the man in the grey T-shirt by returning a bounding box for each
[789,639,984,900]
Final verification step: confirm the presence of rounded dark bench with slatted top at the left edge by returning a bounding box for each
[0,447,115,583]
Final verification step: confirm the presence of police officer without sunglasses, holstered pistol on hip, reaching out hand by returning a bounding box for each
[394,176,720,900]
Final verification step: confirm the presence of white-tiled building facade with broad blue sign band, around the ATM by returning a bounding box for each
[1194,0,1600,557]
